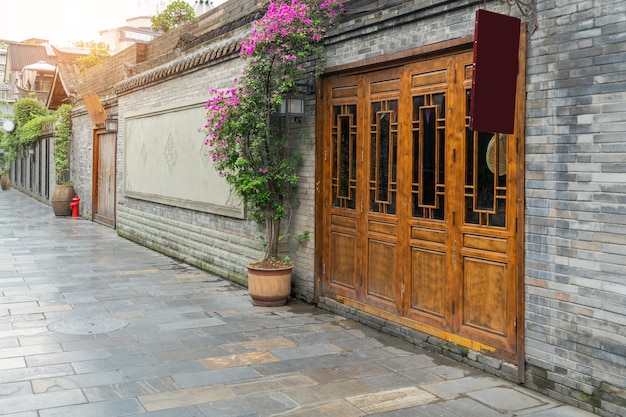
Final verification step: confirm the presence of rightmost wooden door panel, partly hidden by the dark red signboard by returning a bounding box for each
[455,49,518,356]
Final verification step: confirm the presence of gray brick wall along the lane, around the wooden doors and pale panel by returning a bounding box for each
[66,0,626,417]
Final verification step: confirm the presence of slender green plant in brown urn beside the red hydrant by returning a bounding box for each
[50,104,76,216]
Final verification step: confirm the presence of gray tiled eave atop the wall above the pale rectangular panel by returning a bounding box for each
[113,37,242,95]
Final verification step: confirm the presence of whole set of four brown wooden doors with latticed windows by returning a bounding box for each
[321,51,523,358]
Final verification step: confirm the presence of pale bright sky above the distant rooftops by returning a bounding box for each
[0,0,225,46]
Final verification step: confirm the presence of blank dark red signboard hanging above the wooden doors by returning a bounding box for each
[470,10,521,133]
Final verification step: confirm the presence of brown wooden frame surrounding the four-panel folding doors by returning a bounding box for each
[314,35,526,376]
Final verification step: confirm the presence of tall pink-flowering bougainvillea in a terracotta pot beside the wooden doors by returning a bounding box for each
[204,0,342,305]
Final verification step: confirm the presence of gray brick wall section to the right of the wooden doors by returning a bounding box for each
[525,0,626,416]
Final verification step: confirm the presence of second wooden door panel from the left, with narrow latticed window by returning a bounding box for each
[361,69,402,314]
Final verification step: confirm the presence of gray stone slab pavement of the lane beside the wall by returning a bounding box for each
[0,189,592,417]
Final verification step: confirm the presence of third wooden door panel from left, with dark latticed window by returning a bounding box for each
[405,58,454,331]
